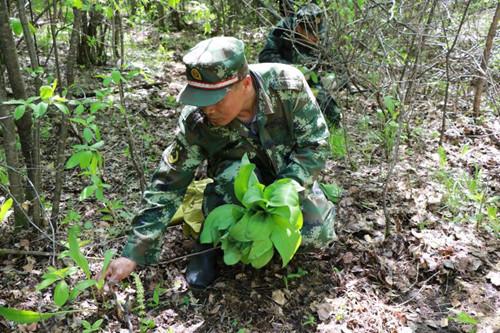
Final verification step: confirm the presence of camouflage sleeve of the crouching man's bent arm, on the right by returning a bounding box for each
[278,79,330,186]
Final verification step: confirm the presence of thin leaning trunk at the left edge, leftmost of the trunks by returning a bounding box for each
[0,63,28,228]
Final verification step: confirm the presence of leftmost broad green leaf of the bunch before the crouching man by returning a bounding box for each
[200,204,243,244]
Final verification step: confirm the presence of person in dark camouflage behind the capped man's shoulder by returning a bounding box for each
[259,4,340,127]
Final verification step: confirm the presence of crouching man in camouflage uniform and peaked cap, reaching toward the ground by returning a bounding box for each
[106,37,335,287]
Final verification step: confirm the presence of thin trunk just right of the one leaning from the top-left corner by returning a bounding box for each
[17,0,42,225]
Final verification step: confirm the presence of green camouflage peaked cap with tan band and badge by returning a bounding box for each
[177,37,248,107]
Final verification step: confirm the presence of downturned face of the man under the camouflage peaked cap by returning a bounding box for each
[201,81,245,126]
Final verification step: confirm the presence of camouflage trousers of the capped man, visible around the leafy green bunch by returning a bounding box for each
[183,161,337,248]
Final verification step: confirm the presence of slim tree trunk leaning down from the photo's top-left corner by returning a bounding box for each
[0,0,40,224]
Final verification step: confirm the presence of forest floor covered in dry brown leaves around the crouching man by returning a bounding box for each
[0,29,500,333]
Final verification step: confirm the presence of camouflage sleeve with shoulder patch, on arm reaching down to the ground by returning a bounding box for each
[122,115,204,265]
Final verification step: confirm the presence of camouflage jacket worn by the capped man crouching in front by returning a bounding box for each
[123,64,329,264]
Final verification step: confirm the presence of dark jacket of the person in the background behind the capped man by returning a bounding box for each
[259,16,323,65]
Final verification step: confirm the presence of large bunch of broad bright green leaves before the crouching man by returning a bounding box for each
[200,155,303,268]
